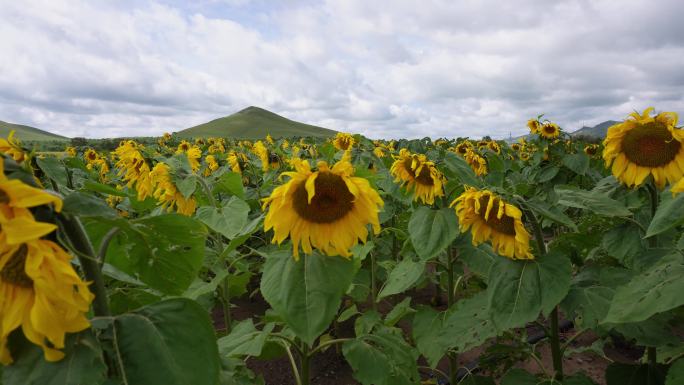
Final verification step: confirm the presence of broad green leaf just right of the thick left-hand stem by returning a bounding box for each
[88,214,207,295]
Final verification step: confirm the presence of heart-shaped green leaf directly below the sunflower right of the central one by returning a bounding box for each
[408,206,459,260]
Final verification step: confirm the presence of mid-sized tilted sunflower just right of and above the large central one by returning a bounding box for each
[390,148,444,205]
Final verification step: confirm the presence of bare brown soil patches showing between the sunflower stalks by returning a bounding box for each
[214,284,643,385]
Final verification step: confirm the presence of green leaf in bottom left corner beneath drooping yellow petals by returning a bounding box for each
[0,330,107,385]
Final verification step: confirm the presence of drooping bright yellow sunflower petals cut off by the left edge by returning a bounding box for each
[0,158,93,365]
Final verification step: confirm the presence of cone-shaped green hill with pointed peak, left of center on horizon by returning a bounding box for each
[177,106,337,139]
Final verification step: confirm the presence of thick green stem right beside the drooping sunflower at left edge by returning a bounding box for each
[58,214,111,317]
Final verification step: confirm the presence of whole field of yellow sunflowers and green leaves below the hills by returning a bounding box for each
[0,108,684,385]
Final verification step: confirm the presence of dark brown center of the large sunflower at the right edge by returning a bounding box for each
[622,122,681,167]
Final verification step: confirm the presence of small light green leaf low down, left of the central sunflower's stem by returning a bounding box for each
[218,318,275,357]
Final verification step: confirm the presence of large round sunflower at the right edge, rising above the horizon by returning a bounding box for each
[603,107,684,189]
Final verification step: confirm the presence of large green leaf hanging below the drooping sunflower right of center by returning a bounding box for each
[487,252,572,330]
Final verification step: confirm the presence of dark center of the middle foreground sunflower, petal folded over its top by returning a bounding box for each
[292,171,354,223]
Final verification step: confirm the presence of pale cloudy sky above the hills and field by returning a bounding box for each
[0,0,684,138]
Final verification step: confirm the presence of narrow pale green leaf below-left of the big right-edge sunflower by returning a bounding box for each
[554,186,632,217]
